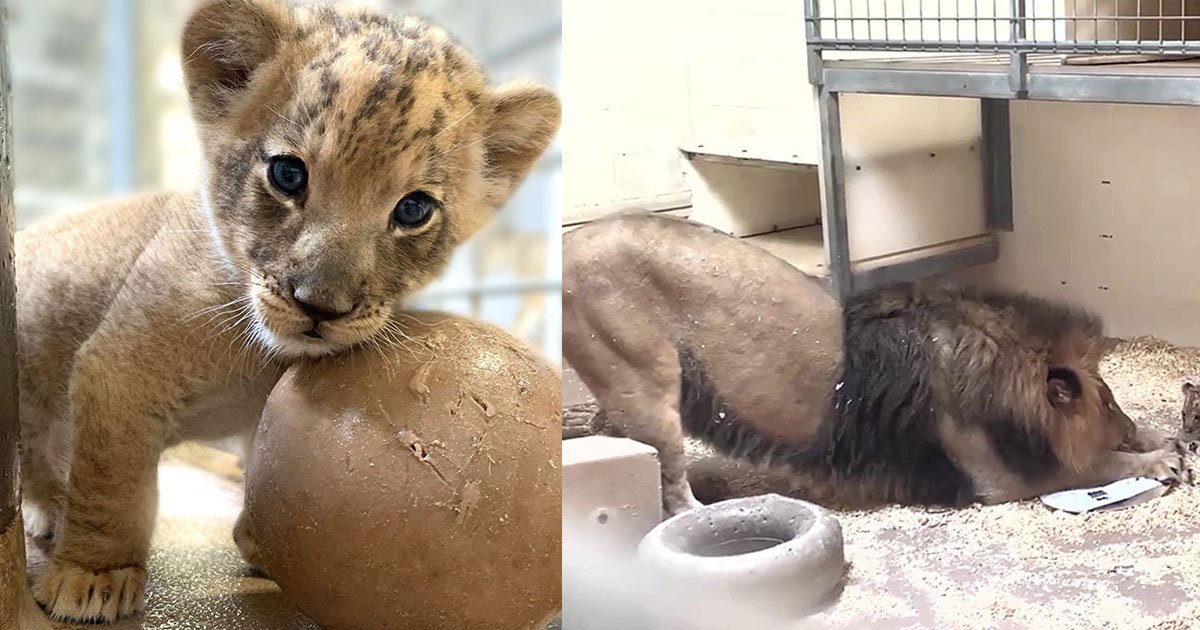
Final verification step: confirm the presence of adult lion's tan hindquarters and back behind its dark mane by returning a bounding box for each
[563,217,841,514]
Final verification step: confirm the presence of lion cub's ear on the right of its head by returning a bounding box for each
[484,82,563,208]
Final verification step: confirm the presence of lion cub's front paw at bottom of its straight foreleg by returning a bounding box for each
[34,558,146,623]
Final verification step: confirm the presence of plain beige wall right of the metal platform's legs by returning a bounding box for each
[966,102,1200,346]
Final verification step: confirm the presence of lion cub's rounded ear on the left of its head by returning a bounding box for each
[182,0,292,122]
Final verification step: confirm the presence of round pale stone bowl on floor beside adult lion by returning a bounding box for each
[637,494,846,629]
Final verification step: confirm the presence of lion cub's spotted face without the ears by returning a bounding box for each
[208,28,494,355]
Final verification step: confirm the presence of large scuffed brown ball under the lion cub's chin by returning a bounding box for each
[246,313,562,630]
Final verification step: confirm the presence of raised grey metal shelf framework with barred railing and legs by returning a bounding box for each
[804,0,1200,299]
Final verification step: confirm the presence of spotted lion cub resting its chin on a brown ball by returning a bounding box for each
[17,0,560,622]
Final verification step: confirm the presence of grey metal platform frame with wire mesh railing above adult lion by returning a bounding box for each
[804,0,1200,298]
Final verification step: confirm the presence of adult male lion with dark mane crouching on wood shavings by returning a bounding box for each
[563,215,1186,514]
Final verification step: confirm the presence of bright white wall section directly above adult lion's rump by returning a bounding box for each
[560,0,689,222]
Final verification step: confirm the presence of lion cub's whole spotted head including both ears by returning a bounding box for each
[184,0,559,356]
